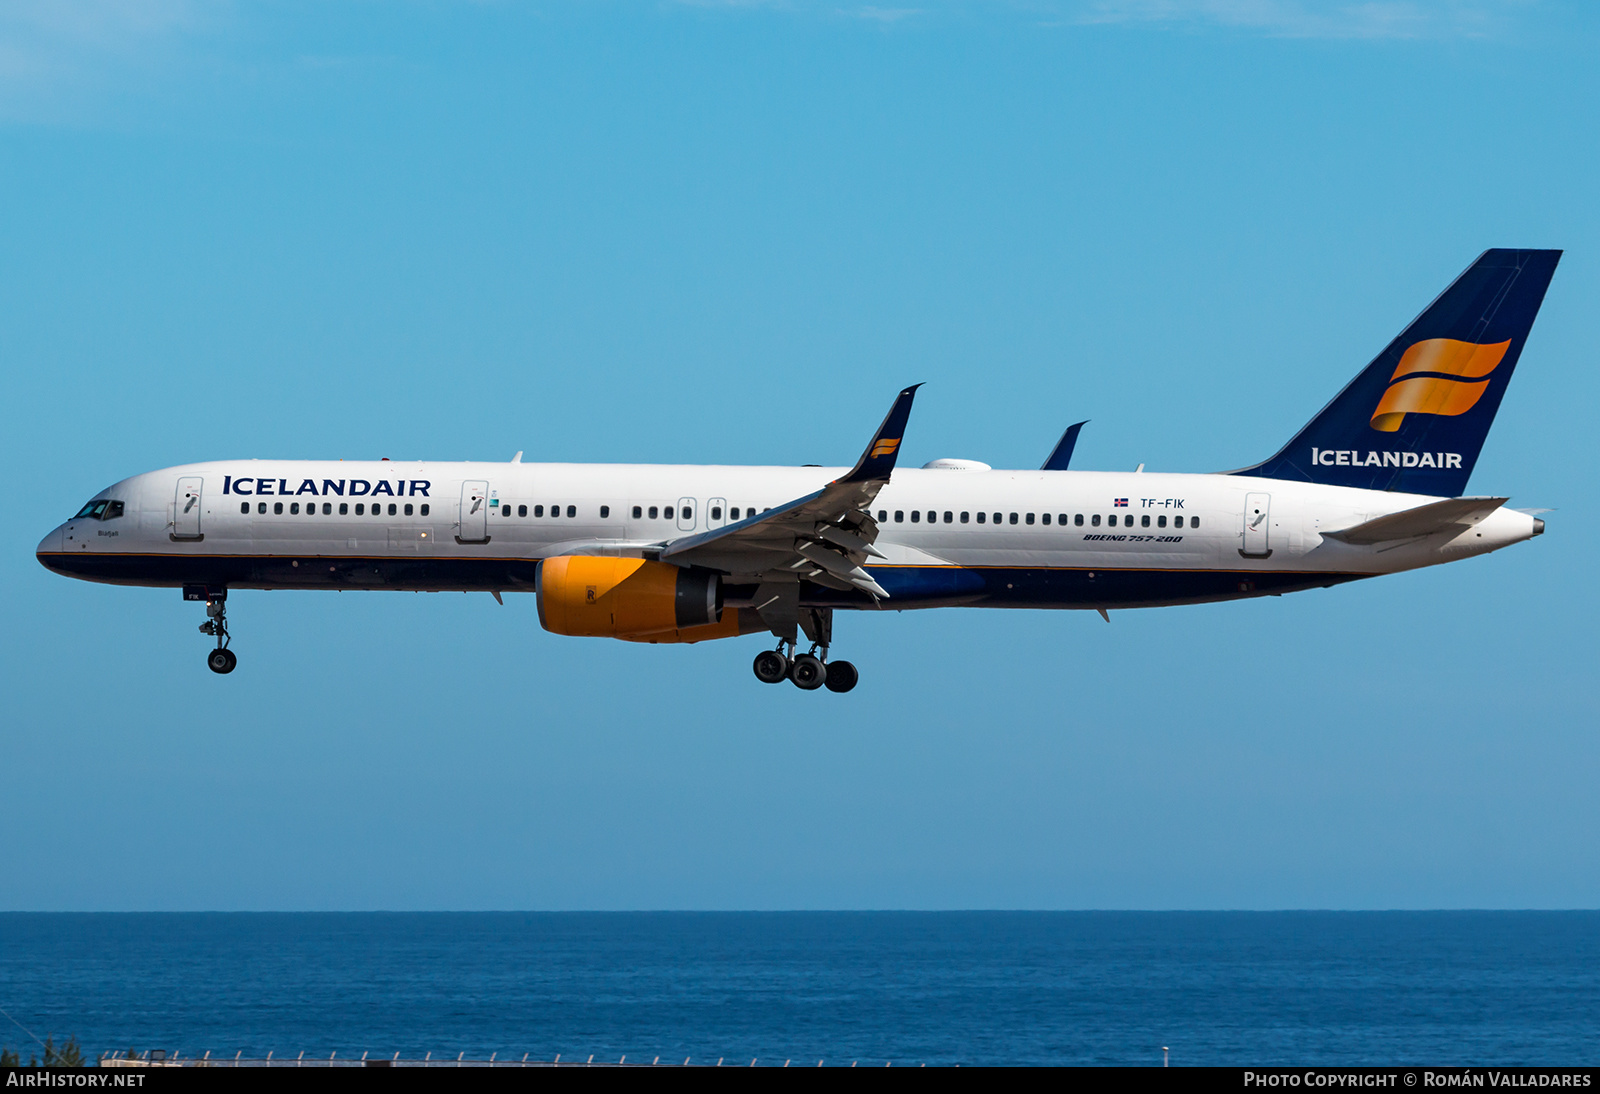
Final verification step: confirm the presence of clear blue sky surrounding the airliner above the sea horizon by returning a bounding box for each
[0,0,1600,908]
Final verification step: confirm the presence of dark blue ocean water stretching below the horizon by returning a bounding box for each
[0,912,1600,1065]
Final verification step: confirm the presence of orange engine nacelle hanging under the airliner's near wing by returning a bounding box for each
[536,555,739,641]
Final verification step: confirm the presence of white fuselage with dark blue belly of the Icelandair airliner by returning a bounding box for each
[38,461,1536,608]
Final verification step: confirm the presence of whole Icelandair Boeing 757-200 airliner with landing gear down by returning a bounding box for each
[37,250,1562,693]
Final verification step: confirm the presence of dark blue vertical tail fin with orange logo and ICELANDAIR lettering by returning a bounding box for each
[1234,250,1562,497]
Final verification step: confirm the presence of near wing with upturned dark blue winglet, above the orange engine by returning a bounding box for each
[661,384,922,600]
